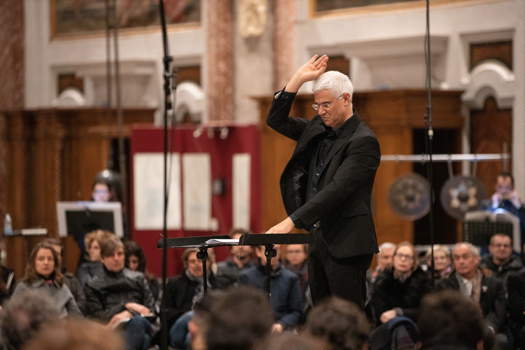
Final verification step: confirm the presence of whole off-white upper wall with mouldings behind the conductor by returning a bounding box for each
[24,0,525,195]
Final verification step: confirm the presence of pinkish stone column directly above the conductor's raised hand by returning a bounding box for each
[273,1,297,90]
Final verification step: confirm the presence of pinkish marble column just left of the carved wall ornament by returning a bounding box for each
[205,0,234,123]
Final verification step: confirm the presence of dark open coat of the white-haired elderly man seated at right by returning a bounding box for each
[436,272,507,332]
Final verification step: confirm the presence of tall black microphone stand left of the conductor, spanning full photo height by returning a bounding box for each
[159,0,173,350]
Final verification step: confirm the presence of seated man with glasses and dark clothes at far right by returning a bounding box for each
[481,233,523,286]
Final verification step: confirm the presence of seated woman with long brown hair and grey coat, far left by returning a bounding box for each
[13,242,82,317]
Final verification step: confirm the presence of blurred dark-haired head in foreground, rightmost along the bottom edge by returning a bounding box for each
[417,291,484,350]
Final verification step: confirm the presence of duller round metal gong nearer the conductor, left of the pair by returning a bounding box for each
[388,174,430,220]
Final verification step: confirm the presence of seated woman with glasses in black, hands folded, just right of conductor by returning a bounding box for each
[371,242,431,324]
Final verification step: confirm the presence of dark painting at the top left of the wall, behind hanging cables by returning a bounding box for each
[50,0,201,36]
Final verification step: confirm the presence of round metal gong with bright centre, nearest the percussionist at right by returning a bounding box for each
[441,176,487,220]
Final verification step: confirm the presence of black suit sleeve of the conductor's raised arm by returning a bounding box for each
[266,90,308,141]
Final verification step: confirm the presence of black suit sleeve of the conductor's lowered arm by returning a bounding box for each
[293,136,380,228]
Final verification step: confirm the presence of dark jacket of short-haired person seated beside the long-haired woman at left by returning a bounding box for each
[84,268,155,322]
